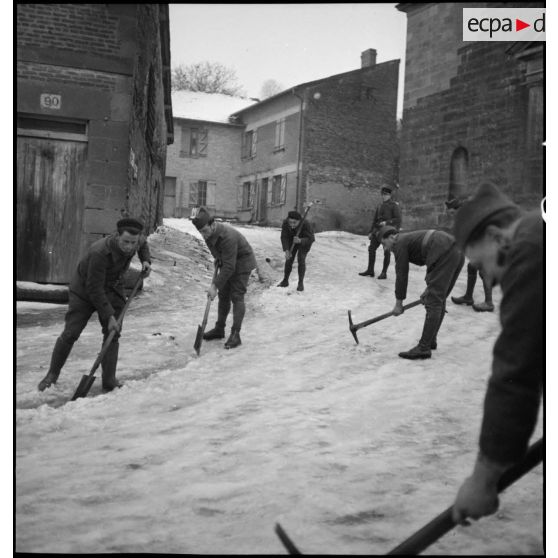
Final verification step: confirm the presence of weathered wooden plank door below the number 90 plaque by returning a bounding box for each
[17,136,87,283]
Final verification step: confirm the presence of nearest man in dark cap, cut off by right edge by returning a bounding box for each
[452,183,545,524]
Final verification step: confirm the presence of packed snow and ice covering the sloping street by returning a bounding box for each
[15,219,543,555]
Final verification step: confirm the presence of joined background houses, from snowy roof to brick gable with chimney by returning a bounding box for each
[165,49,399,233]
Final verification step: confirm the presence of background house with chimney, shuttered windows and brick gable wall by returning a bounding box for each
[232,49,399,233]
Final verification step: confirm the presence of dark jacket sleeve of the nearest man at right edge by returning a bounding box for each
[480,211,545,464]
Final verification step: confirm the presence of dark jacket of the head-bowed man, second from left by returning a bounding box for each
[205,222,256,290]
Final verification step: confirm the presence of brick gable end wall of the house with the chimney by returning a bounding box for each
[302,60,399,233]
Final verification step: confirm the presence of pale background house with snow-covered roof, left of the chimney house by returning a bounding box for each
[164,91,256,219]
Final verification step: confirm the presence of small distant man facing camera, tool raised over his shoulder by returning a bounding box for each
[277,211,315,291]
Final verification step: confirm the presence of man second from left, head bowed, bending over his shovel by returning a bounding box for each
[192,207,256,349]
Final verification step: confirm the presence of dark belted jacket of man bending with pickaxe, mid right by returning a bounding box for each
[392,230,455,300]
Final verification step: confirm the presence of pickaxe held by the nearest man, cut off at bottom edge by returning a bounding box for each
[275,438,544,556]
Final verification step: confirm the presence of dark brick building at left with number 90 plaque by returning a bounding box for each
[17,3,173,283]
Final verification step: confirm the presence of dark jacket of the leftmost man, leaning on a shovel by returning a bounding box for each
[70,234,151,319]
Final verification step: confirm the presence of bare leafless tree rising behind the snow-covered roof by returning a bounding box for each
[171,61,244,96]
